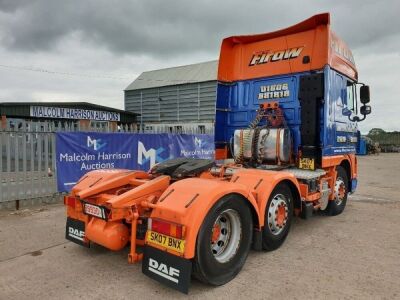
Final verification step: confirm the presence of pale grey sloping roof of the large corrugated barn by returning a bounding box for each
[125,60,218,91]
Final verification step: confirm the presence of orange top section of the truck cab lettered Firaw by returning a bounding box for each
[218,13,358,82]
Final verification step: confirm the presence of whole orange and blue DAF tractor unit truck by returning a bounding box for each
[64,13,371,293]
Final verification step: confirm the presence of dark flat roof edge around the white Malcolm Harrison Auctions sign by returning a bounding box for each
[0,102,140,123]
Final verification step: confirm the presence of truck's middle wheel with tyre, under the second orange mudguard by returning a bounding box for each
[262,184,294,251]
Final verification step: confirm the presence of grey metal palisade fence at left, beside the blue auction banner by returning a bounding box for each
[0,119,135,209]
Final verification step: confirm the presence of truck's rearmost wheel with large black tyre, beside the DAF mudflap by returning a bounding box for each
[193,195,253,286]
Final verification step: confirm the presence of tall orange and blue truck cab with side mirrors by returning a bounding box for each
[215,14,371,183]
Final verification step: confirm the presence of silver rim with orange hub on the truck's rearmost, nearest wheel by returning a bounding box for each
[211,209,242,263]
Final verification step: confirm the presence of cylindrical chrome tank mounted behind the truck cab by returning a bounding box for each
[233,128,292,163]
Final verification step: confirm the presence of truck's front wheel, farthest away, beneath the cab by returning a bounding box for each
[326,166,349,216]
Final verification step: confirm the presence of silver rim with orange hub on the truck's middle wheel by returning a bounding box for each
[267,194,289,235]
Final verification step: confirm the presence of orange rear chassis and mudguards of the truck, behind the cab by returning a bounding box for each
[67,167,300,262]
